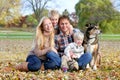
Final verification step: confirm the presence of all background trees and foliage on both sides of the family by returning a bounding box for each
[0,0,120,34]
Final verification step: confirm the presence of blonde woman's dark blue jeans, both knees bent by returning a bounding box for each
[26,51,61,71]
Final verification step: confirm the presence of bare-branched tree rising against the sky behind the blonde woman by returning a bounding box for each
[26,0,51,22]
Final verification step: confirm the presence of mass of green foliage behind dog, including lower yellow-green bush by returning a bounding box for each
[75,0,120,33]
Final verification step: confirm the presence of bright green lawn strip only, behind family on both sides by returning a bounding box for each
[0,30,120,40]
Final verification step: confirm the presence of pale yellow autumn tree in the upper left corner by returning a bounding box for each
[0,0,20,24]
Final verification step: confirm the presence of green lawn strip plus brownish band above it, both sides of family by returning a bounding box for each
[0,28,120,41]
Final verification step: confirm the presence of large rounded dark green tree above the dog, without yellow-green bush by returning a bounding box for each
[75,0,118,28]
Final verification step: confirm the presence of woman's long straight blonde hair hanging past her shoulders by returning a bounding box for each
[36,17,54,49]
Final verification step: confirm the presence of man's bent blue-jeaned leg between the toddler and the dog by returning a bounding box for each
[78,53,92,70]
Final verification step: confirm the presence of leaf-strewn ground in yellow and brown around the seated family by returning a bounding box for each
[0,40,120,80]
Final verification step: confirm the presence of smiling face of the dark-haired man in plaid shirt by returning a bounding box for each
[59,19,70,33]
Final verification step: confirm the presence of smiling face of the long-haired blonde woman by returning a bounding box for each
[43,18,53,32]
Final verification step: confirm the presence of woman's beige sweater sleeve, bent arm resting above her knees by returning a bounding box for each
[32,41,49,57]
